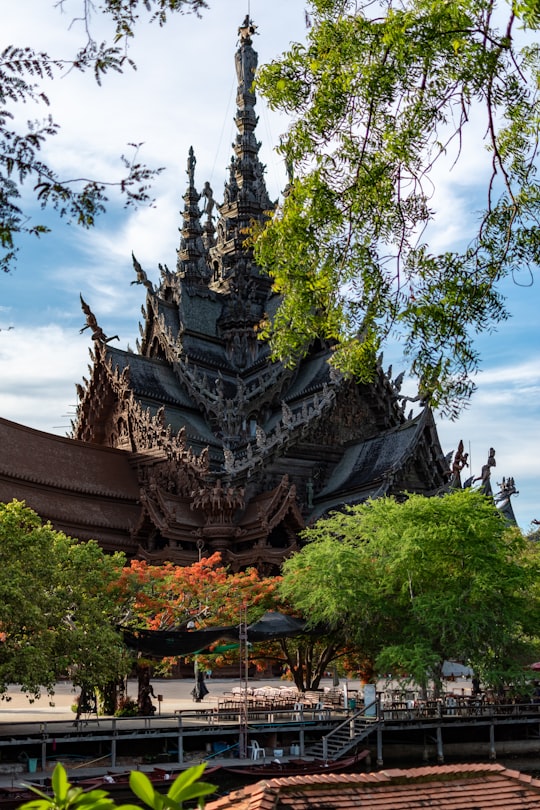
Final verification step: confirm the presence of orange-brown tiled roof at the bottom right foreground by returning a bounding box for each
[206,763,540,810]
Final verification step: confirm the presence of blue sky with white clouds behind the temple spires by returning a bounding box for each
[0,0,540,532]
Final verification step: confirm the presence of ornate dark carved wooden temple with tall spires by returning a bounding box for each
[0,21,452,574]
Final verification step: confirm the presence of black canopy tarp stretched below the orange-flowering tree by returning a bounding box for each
[122,610,306,658]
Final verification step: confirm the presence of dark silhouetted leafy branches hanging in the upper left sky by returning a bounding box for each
[0,0,207,271]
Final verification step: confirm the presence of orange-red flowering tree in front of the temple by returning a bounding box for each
[112,553,349,691]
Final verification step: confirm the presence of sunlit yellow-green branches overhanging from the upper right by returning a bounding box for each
[255,0,540,416]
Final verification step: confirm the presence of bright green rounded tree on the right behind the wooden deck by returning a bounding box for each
[280,490,540,685]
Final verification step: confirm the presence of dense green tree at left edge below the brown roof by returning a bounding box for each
[0,501,127,695]
